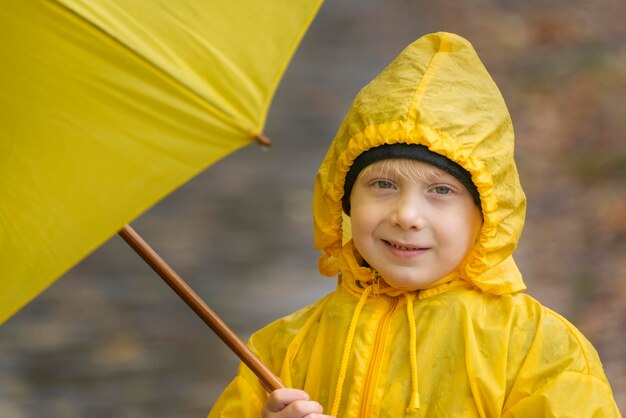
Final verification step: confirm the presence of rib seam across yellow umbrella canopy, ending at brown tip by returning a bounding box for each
[47,0,258,142]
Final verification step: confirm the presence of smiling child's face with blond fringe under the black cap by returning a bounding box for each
[350,160,482,290]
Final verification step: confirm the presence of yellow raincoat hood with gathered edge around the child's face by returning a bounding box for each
[313,32,526,295]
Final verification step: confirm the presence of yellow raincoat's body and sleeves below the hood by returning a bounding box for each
[209,284,620,418]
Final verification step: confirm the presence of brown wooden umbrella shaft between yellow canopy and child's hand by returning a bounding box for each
[118,225,285,392]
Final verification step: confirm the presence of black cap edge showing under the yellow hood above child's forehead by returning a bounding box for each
[341,143,481,215]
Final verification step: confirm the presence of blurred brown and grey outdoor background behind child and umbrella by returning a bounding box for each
[0,0,626,418]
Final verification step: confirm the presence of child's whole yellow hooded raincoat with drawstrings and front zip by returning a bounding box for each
[209,33,620,418]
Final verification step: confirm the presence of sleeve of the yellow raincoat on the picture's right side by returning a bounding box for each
[502,309,621,418]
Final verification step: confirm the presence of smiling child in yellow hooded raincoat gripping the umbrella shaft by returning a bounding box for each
[209,33,620,418]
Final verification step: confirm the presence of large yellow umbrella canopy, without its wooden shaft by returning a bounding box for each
[0,0,321,323]
